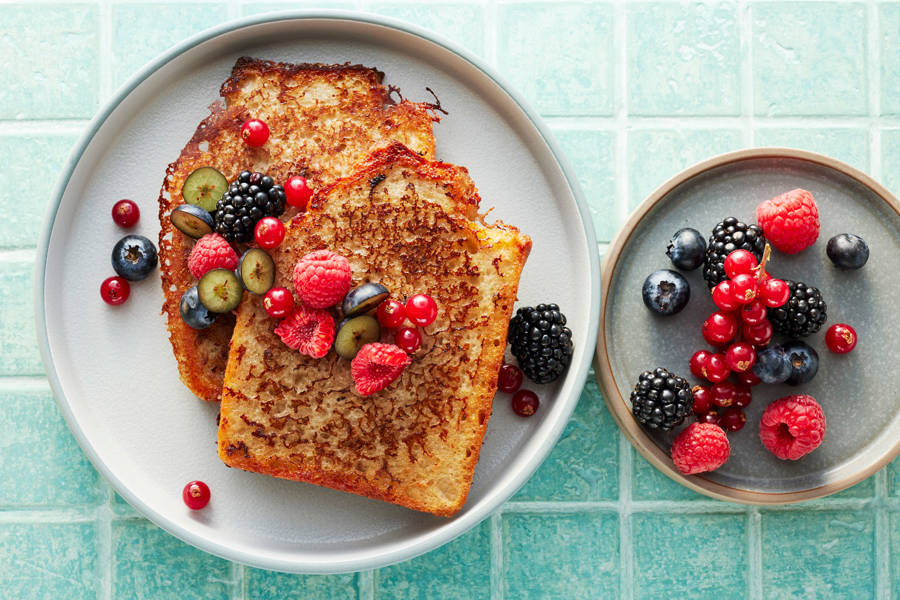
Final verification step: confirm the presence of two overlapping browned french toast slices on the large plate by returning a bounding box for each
[159,58,531,516]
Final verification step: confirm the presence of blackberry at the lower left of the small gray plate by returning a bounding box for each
[631,368,694,431]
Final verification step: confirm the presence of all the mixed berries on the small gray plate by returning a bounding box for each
[631,189,869,474]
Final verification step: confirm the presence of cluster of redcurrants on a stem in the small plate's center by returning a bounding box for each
[690,246,790,431]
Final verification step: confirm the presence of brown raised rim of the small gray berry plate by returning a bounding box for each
[593,146,900,506]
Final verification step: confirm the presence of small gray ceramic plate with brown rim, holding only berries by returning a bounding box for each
[596,148,900,504]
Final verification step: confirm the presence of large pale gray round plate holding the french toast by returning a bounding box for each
[36,11,600,572]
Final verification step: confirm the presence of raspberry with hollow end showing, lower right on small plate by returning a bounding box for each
[759,394,825,460]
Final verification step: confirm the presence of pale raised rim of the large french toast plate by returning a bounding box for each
[32,8,600,574]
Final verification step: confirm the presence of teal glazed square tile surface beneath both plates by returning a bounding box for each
[0,0,900,600]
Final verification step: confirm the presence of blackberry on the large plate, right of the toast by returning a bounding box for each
[509,304,573,383]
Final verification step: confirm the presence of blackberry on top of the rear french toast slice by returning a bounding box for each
[213,171,286,243]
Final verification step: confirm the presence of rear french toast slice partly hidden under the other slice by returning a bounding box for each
[159,57,437,401]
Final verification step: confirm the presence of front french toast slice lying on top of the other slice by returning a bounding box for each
[218,144,531,516]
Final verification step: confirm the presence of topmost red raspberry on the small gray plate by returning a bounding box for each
[756,189,819,254]
